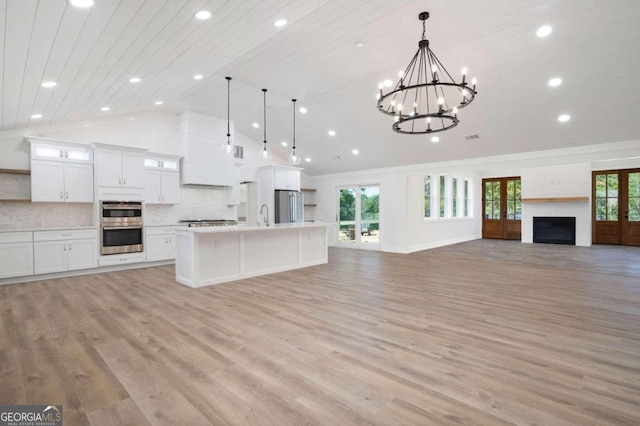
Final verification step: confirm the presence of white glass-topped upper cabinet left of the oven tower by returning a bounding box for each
[29,137,94,203]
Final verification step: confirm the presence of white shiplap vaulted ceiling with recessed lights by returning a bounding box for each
[0,0,640,175]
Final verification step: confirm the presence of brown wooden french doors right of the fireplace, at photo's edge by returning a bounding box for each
[591,169,640,246]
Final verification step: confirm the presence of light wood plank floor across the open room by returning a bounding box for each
[0,240,640,426]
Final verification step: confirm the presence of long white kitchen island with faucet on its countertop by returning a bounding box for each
[176,222,331,287]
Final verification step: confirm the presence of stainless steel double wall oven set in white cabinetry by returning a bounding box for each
[100,201,143,255]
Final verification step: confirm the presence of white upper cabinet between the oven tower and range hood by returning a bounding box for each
[144,156,180,204]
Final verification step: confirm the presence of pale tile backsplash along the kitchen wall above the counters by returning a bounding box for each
[0,186,237,230]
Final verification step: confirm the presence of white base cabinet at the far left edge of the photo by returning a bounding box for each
[0,232,33,278]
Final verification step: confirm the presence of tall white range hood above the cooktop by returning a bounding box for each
[178,111,239,186]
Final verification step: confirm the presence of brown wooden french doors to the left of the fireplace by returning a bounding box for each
[482,177,522,240]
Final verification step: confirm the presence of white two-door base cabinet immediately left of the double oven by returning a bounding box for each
[33,229,98,274]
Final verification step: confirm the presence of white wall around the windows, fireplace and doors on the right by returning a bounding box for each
[312,140,640,253]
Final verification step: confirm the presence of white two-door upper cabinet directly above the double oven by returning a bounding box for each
[92,144,146,201]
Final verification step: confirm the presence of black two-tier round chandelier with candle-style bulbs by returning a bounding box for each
[377,12,477,134]
